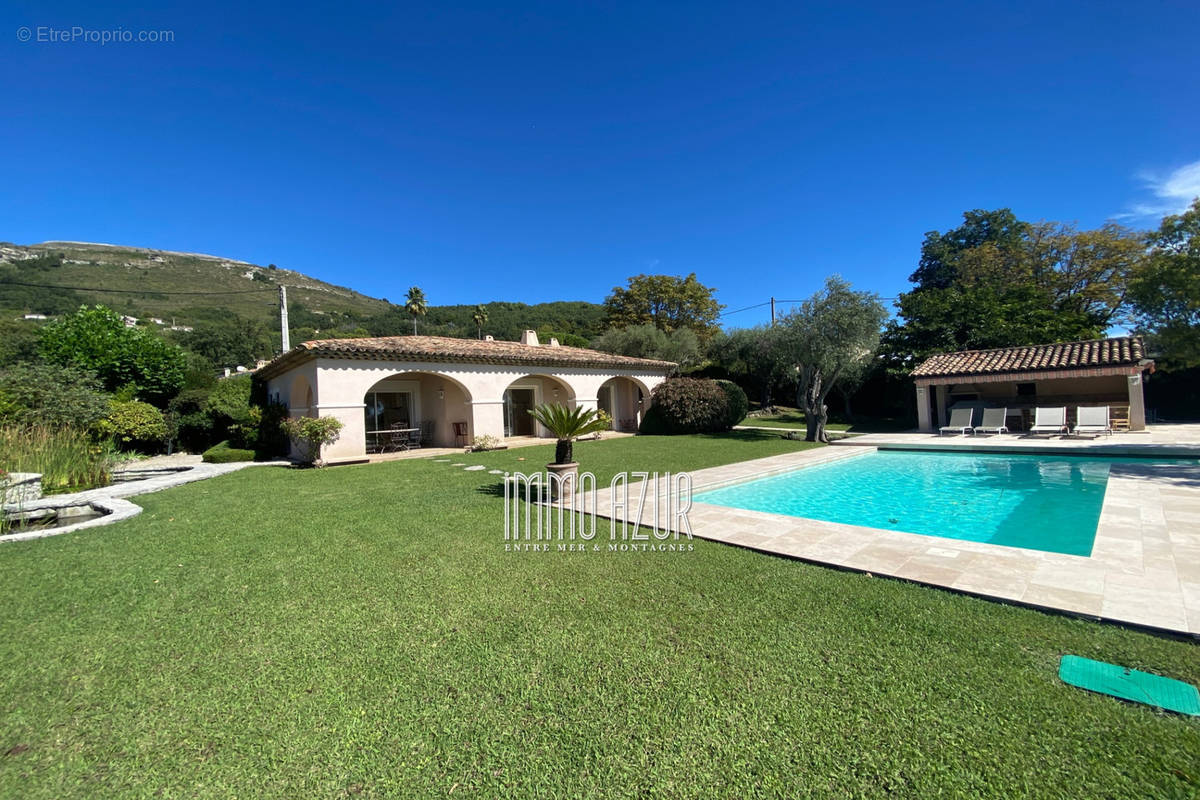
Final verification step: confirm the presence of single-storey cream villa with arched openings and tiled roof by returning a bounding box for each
[258,331,676,462]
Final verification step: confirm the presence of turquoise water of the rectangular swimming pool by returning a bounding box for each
[692,451,1180,555]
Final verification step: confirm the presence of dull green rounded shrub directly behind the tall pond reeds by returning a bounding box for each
[0,363,109,431]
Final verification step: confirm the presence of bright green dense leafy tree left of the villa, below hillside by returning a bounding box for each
[38,306,186,407]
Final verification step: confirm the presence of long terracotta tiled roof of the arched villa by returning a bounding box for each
[262,336,676,375]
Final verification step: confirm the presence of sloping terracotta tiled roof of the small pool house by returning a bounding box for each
[912,336,1146,378]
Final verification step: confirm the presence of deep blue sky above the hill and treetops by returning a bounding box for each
[0,1,1200,325]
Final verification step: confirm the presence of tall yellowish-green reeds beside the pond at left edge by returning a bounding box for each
[0,425,115,493]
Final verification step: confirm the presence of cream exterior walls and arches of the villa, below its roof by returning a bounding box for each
[266,359,666,461]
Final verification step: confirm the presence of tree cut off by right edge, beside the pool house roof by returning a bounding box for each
[1129,198,1200,367]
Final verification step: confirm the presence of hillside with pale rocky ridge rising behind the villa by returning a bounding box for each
[0,241,604,362]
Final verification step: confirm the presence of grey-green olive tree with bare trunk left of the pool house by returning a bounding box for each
[779,276,887,441]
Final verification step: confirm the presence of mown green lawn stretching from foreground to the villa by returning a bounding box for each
[0,433,1200,799]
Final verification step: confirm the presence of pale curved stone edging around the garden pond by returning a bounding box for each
[0,461,292,543]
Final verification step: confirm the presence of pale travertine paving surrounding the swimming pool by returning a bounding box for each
[596,441,1200,636]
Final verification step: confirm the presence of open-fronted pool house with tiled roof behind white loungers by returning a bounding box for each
[912,336,1154,431]
